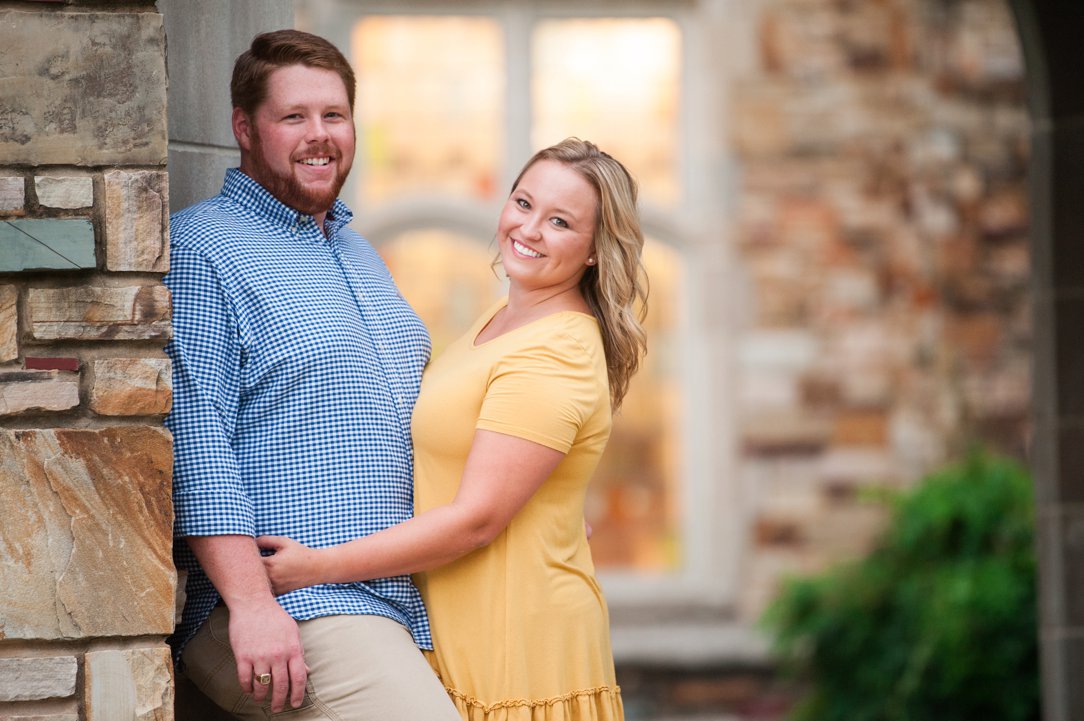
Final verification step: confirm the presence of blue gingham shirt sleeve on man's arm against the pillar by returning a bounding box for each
[165,247,256,538]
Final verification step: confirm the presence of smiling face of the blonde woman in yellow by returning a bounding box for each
[496,160,598,291]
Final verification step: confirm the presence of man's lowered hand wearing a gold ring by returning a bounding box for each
[230,601,309,713]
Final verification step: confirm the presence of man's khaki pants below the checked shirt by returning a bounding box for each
[177,606,461,721]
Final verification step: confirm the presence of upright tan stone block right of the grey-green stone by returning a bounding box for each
[104,170,169,273]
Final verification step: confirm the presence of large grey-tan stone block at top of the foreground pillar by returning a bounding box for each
[0,9,167,167]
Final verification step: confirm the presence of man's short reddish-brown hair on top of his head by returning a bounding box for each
[230,30,357,115]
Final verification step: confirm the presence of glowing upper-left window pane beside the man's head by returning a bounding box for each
[351,16,504,202]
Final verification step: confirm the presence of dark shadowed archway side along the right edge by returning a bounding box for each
[1010,0,1084,721]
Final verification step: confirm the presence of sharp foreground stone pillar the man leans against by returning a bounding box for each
[0,0,176,721]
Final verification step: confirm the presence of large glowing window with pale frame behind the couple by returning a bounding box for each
[295,0,740,654]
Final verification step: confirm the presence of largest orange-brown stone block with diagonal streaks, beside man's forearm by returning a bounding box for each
[0,426,176,641]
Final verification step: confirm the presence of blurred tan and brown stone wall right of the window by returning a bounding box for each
[731,0,1031,622]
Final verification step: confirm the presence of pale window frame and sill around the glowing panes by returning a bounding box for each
[295,0,765,662]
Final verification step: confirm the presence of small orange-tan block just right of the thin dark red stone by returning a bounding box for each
[90,358,173,415]
